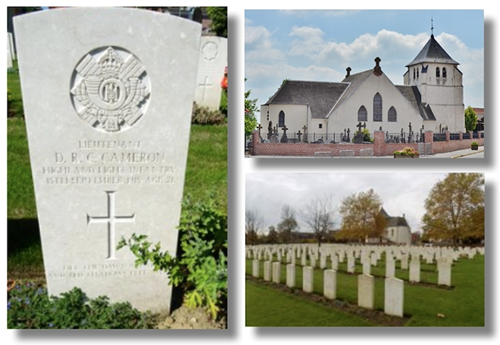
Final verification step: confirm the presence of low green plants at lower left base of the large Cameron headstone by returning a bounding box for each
[7,282,154,329]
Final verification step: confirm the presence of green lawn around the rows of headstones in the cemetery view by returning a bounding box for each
[246,255,485,327]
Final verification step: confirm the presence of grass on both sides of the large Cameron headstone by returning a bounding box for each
[7,117,227,280]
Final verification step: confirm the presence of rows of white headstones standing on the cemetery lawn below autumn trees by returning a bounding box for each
[246,245,484,317]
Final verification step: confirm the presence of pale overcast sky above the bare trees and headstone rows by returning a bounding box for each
[245,173,452,232]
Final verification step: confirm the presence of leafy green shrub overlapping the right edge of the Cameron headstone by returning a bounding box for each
[118,197,227,319]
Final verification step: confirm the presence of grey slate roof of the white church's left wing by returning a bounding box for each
[264,80,349,118]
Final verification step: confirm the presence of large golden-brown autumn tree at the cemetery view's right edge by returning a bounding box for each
[422,173,484,246]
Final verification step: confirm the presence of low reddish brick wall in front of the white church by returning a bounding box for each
[252,131,484,156]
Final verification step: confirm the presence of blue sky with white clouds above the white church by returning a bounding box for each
[245,10,484,114]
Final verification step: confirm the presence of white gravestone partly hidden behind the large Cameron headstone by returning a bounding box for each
[195,36,227,110]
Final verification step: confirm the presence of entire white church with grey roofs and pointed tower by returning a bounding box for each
[260,35,465,137]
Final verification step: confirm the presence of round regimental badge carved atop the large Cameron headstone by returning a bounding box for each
[71,47,150,133]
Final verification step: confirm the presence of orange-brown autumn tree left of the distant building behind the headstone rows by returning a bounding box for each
[338,189,385,241]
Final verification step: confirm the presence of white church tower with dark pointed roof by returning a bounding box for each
[404,29,465,133]
